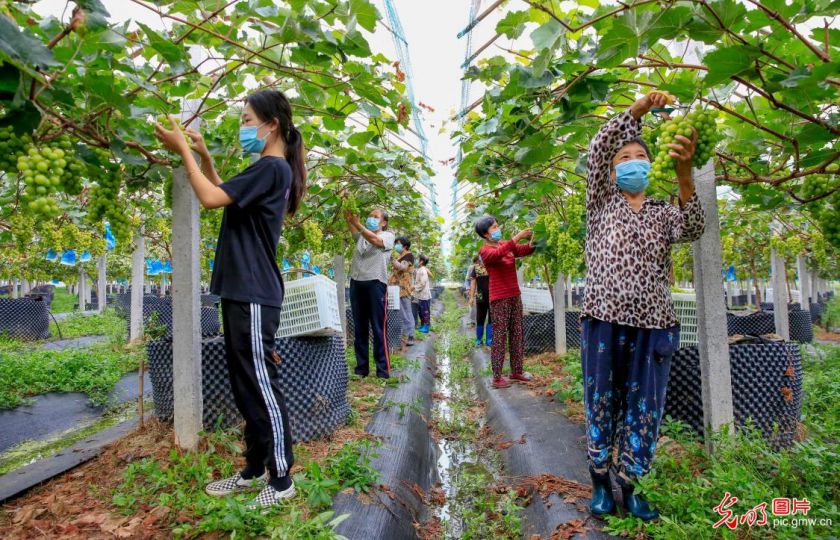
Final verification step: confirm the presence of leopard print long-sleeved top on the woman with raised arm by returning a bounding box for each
[582,111,706,328]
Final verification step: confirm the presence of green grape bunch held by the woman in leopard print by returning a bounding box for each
[651,107,719,181]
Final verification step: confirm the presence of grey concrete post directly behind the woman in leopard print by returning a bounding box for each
[692,161,734,451]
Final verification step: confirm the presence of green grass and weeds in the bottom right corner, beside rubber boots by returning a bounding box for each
[608,347,840,540]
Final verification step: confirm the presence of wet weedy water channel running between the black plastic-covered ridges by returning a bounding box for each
[432,300,506,539]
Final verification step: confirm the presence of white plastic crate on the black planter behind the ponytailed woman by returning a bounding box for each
[277,275,342,337]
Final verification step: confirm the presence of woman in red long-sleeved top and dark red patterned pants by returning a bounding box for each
[475,216,534,388]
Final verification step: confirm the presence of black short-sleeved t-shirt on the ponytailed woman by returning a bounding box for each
[210,156,292,307]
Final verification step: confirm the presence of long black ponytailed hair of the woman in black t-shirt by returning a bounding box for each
[246,90,306,216]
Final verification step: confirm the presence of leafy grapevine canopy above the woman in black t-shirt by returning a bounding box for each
[0,0,442,274]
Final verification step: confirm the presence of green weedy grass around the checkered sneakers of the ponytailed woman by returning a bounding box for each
[111,431,379,540]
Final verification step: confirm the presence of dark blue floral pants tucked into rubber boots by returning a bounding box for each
[580,318,680,485]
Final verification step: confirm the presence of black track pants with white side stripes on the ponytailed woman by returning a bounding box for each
[222,299,294,478]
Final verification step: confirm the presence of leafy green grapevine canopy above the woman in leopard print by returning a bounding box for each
[456,0,840,278]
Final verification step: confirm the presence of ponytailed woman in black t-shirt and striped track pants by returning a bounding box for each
[155,90,306,508]
